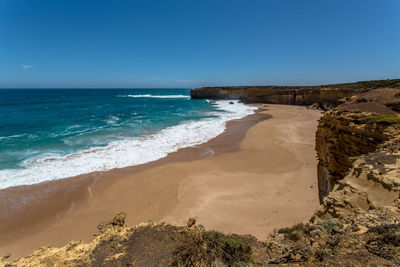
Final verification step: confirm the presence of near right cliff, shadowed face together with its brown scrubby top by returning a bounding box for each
[315,89,400,201]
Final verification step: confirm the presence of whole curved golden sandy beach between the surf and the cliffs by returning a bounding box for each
[0,105,321,258]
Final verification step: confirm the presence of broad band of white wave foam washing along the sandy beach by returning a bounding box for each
[0,100,256,189]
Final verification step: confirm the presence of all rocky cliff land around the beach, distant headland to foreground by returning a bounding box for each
[0,80,400,266]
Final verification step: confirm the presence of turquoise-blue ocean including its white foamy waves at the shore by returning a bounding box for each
[0,89,255,189]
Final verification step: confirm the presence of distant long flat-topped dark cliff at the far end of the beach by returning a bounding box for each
[190,79,400,109]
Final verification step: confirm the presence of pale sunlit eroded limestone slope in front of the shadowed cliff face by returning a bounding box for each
[314,126,400,221]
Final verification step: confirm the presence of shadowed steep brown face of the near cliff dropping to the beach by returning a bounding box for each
[315,110,393,201]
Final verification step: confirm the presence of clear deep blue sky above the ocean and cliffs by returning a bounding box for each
[0,0,400,88]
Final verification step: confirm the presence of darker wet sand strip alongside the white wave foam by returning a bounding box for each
[0,107,270,257]
